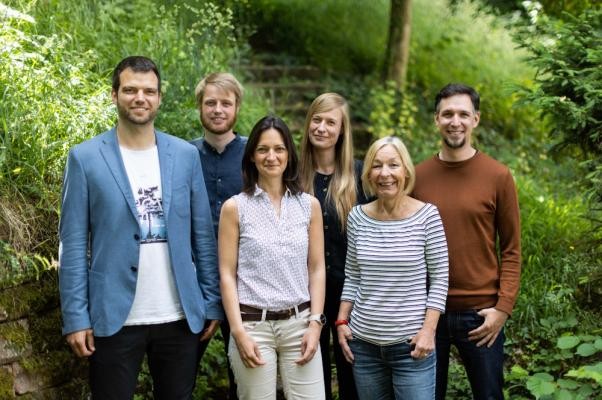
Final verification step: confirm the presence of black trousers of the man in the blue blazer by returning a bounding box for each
[90,320,200,400]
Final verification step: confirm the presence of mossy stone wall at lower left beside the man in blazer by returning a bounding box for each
[0,270,88,400]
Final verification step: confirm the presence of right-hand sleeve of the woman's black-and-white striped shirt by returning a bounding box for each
[424,206,449,312]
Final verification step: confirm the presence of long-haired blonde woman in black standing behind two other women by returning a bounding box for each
[300,93,366,400]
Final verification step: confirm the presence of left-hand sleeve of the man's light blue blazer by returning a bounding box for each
[59,149,91,335]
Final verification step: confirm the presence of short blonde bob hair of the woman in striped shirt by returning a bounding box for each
[362,136,416,196]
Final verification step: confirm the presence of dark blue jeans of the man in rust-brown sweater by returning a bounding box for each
[437,310,504,400]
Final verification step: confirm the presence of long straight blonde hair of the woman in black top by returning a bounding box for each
[300,93,357,230]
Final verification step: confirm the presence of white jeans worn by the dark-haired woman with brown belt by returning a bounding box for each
[228,310,325,400]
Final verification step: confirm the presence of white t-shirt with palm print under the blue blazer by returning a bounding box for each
[120,146,184,325]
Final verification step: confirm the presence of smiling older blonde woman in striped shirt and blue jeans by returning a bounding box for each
[335,137,448,400]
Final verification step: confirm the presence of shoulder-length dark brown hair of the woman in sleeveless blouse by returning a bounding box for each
[242,115,301,195]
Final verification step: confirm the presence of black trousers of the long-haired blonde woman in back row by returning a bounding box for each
[320,279,357,400]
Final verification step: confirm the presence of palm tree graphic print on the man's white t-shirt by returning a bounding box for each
[136,186,167,244]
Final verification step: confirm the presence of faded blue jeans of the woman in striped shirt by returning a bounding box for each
[349,338,435,400]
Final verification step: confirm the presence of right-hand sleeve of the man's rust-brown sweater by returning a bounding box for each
[495,170,521,315]
